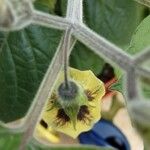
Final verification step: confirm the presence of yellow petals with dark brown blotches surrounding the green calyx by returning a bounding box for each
[38,68,105,138]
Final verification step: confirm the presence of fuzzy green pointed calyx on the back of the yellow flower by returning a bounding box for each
[58,81,88,130]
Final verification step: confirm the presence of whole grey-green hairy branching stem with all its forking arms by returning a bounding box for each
[0,0,150,150]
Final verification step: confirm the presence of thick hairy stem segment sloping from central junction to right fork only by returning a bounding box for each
[74,25,132,70]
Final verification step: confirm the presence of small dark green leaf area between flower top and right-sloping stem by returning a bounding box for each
[70,42,105,75]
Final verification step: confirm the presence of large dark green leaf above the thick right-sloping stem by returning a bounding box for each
[84,0,143,47]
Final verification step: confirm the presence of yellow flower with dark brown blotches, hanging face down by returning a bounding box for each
[37,68,105,138]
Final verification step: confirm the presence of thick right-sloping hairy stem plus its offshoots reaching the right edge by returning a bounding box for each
[73,24,150,78]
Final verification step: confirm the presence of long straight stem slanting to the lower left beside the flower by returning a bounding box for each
[20,38,74,150]
